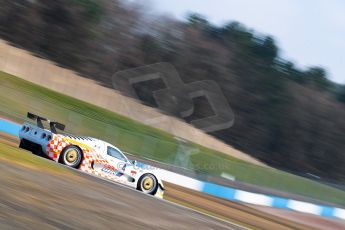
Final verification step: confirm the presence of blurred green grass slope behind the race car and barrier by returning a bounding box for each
[0,72,345,205]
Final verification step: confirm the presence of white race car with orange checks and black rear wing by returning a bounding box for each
[19,113,164,198]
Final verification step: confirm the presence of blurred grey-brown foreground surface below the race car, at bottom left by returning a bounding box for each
[0,143,243,229]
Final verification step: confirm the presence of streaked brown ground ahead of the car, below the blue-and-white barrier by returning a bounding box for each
[165,183,345,229]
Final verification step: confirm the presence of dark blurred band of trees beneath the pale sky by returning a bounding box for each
[0,0,345,182]
